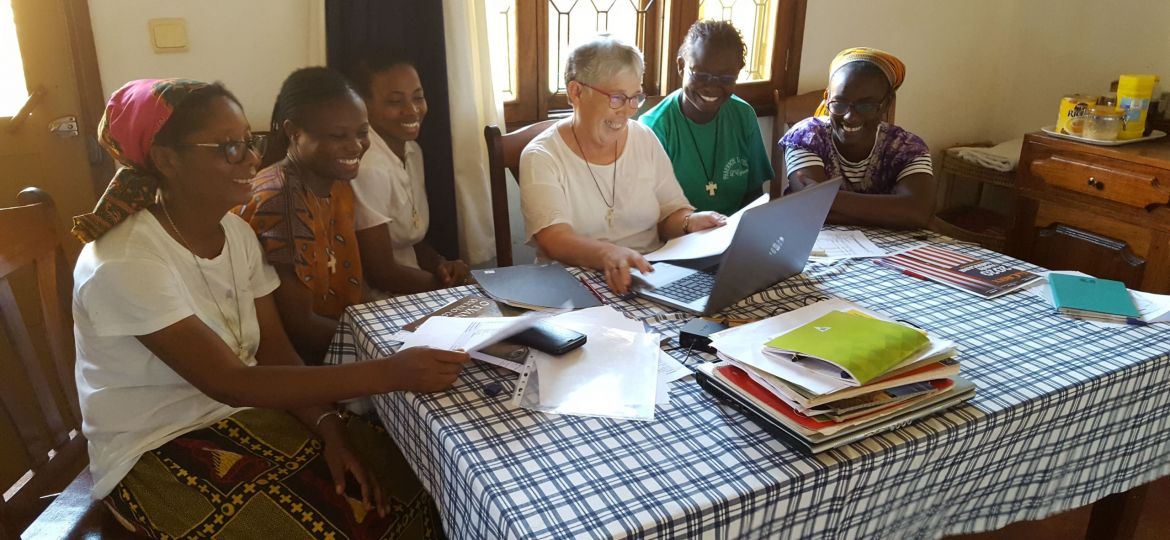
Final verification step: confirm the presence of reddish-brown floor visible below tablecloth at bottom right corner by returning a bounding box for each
[947,477,1170,540]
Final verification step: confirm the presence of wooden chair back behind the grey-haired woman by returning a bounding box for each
[483,118,557,266]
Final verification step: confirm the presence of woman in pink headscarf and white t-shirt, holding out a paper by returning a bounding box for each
[73,79,468,538]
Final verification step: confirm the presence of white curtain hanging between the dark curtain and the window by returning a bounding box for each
[442,0,504,264]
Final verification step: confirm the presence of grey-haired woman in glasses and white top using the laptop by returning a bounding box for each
[519,37,725,295]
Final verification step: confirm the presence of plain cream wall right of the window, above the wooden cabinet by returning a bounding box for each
[800,0,1170,153]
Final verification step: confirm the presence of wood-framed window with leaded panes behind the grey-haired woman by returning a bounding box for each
[487,0,805,126]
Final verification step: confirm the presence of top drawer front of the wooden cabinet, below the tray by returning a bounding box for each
[1031,154,1170,208]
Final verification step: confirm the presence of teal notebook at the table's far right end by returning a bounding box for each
[1048,274,1141,323]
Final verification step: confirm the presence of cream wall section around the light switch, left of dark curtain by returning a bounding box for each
[89,0,324,130]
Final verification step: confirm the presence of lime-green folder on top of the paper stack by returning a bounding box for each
[764,311,930,385]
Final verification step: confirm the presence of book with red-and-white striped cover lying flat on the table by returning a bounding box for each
[874,245,1040,298]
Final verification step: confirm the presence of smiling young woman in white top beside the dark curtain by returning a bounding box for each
[352,57,470,293]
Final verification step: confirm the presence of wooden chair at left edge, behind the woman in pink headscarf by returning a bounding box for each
[0,188,88,538]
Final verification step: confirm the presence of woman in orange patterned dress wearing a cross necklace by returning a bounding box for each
[238,68,370,362]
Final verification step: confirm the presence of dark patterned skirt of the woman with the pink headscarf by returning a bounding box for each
[104,409,443,540]
